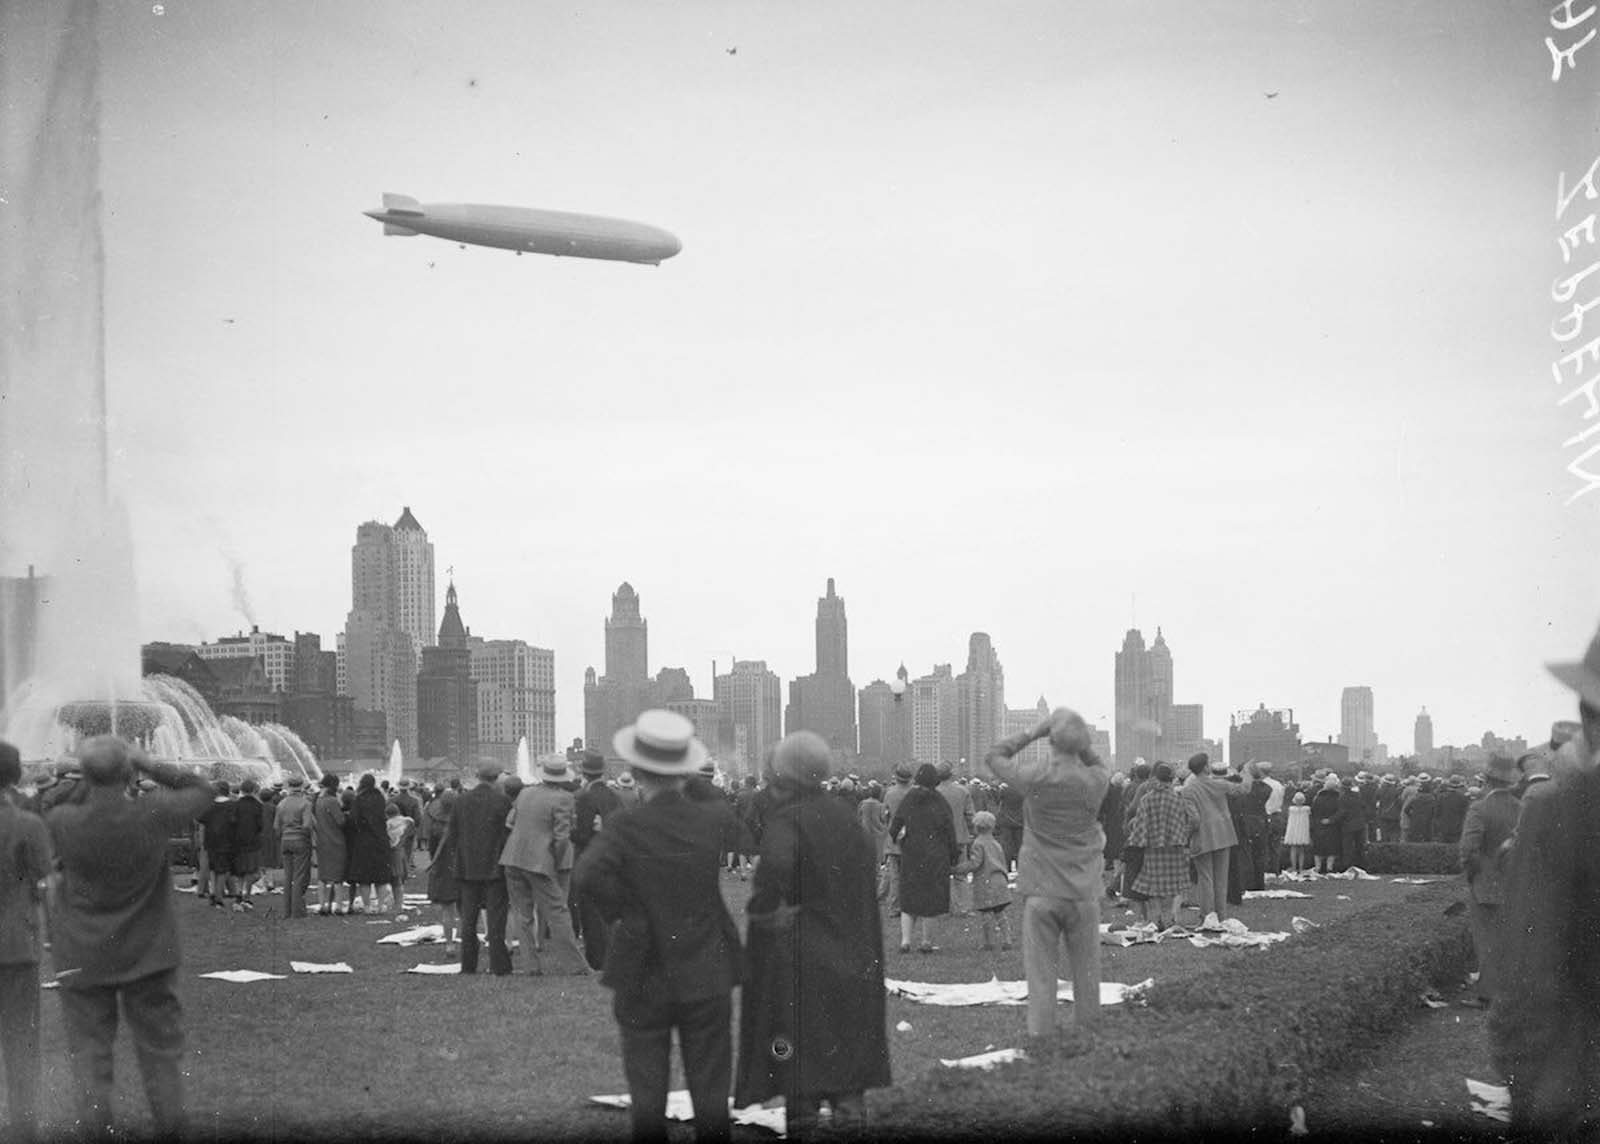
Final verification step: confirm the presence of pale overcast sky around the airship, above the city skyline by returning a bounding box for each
[56,0,1600,750]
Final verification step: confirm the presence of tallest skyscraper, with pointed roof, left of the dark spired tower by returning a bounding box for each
[344,507,435,755]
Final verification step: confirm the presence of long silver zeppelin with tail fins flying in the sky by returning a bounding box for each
[362,195,683,266]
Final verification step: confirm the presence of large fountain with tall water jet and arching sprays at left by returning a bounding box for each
[0,0,320,793]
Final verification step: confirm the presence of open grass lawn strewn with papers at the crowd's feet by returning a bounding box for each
[21,877,1452,1139]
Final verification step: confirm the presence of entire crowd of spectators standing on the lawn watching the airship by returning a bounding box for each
[0,620,1600,1139]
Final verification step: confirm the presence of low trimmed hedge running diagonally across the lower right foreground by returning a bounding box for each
[870,885,1472,1139]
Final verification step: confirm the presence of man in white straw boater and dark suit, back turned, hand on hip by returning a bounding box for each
[576,710,741,1141]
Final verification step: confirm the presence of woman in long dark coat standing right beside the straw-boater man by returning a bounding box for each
[734,731,889,1136]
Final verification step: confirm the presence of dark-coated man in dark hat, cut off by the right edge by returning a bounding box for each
[1490,634,1600,1139]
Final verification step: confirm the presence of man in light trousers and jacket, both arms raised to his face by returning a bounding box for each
[984,707,1110,1037]
